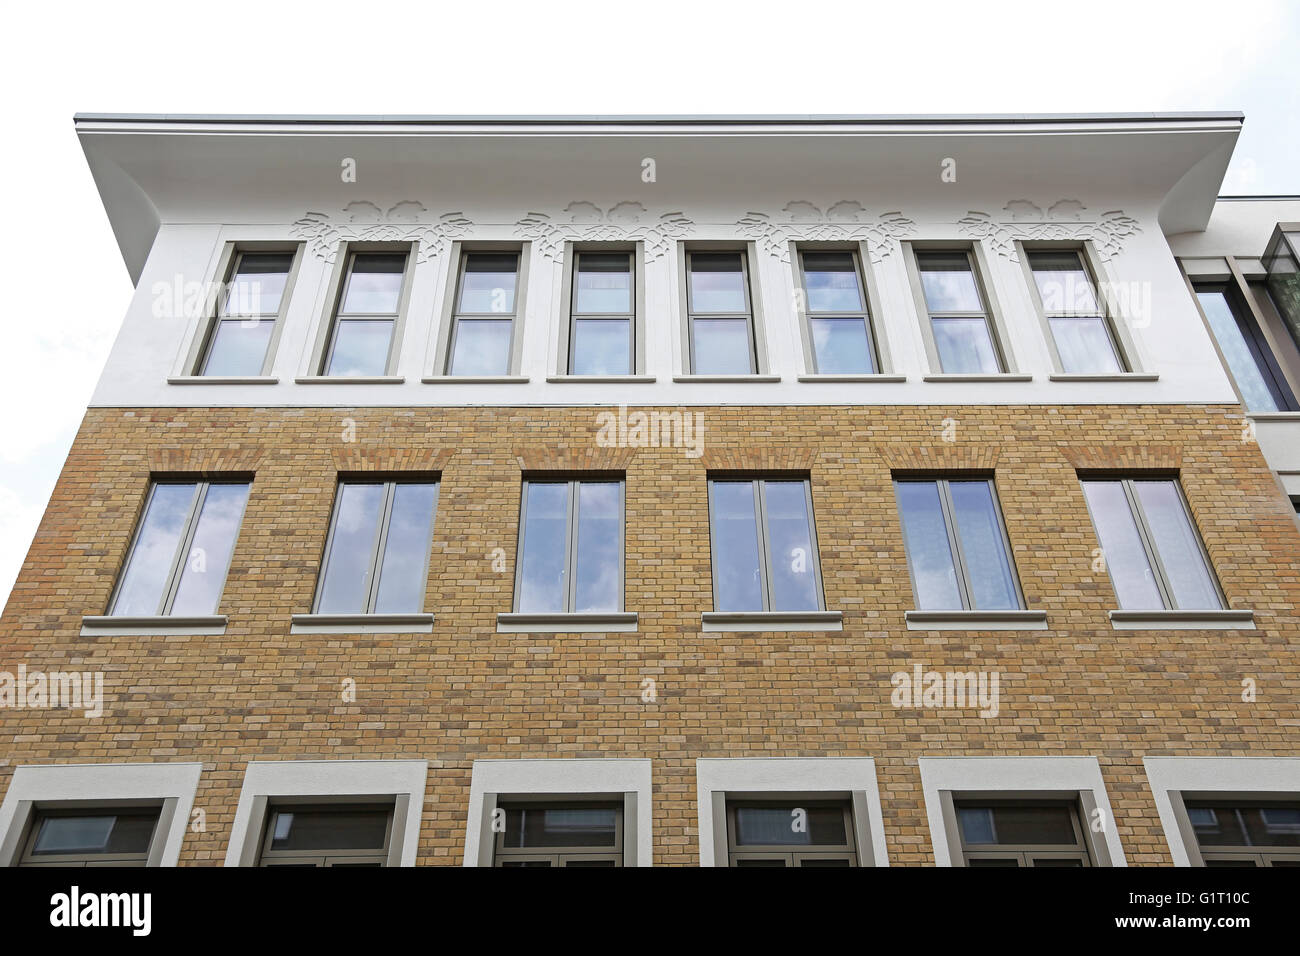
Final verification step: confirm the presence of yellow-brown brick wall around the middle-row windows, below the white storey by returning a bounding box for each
[0,406,1300,865]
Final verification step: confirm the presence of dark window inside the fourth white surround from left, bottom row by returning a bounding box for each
[727,800,858,866]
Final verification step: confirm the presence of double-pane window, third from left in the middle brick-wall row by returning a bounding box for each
[515,480,623,614]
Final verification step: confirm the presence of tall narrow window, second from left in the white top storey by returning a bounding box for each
[324,252,408,376]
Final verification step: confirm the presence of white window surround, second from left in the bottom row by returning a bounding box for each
[225,760,429,866]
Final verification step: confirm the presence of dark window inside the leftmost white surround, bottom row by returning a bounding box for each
[18,806,159,866]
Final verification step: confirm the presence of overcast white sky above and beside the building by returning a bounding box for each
[0,0,1300,600]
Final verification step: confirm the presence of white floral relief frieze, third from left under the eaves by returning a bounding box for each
[736,199,917,263]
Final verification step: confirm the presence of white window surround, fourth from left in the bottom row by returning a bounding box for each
[696,757,889,866]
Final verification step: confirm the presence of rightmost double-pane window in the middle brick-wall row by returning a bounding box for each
[1083,479,1223,610]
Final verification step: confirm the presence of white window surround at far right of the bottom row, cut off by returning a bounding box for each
[1143,757,1300,866]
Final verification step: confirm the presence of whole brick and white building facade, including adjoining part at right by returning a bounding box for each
[0,113,1300,866]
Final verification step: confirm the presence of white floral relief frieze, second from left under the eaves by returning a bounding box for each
[515,200,694,261]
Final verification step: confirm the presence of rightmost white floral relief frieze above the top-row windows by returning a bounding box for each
[957,199,1141,261]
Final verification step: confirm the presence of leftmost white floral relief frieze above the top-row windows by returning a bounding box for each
[293,199,473,263]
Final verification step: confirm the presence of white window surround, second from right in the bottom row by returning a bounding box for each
[917,757,1128,866]
